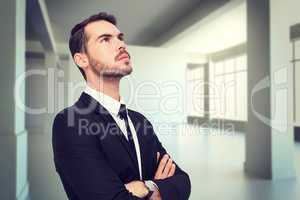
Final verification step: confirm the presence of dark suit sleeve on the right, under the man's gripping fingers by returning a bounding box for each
[148,122,191,200]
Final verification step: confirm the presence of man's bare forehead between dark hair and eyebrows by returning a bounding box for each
[84,20,120,38]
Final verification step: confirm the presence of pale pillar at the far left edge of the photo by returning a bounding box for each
[0,0,29,200]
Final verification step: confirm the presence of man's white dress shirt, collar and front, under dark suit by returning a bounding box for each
[84,85,142,180]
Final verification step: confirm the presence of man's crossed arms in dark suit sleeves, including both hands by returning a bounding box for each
[52,115,191,200]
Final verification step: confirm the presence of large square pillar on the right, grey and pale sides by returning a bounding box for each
[245,0,295,179]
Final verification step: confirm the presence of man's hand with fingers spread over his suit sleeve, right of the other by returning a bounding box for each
[154,152,176,180]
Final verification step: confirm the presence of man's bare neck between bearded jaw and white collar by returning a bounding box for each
[87,77,120,101]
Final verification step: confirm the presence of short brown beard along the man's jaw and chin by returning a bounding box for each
[89,58,132,78]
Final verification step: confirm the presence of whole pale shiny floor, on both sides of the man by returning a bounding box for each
[28,124,300,200]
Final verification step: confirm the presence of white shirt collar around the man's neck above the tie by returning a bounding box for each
[84,85,125,115]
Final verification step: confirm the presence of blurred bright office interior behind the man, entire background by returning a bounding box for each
[0,0,300,200]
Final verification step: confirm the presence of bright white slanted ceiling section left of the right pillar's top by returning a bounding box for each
[162,0,247,54]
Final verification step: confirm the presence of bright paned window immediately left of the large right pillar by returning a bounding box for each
[209,54,247,121]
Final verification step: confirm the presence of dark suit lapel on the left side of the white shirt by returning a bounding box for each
[80,93,139,177]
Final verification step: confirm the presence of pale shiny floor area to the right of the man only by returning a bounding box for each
[178,125,300,200]
